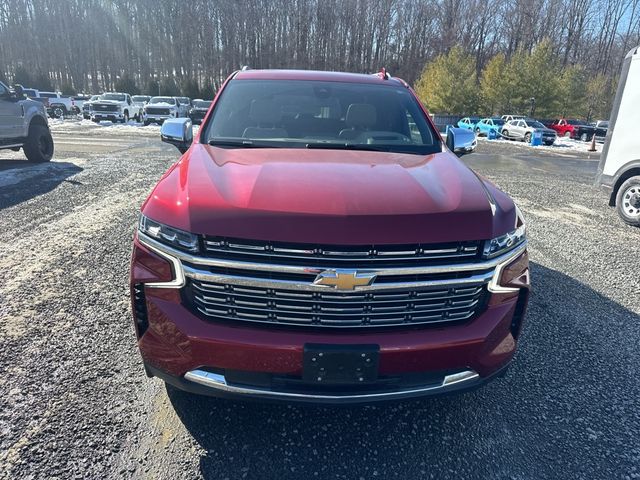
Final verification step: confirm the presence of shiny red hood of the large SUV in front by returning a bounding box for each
[142,144,515,245]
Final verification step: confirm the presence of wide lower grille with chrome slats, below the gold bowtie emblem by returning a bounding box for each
[185,280,486,327]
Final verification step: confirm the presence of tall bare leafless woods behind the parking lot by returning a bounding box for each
[0,0,640,117]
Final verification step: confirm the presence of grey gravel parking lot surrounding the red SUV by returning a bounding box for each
[0,122,640,479]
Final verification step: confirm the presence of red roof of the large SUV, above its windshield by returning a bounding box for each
[233,70,406,86]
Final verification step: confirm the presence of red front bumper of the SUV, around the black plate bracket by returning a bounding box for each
[132,234,529,403]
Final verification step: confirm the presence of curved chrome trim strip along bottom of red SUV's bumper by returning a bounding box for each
[184,370,480,401]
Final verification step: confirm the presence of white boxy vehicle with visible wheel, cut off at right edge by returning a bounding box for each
[596,46,640,227]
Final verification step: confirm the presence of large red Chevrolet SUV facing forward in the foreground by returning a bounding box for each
[131,70,529,403]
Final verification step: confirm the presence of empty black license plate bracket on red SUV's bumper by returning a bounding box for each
[302,343,380,385]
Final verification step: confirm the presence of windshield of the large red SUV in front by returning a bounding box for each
[202,80,441,155]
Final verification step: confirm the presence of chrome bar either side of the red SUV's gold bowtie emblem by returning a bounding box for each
[138,232,527,276]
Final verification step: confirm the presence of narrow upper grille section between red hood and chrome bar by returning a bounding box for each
[203,237,480,268]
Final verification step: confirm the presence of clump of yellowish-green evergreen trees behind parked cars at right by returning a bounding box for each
[416,39,617,120]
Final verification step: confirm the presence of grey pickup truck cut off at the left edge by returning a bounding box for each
[0,82,53,162]
